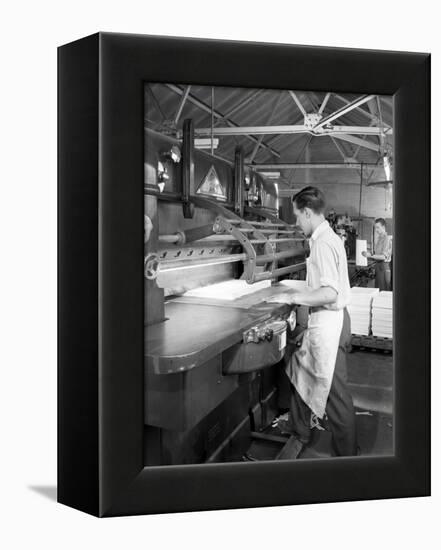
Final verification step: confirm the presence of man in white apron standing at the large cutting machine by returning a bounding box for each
[272,187,357,456]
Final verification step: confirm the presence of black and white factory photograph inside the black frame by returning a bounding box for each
[144,82,400,466]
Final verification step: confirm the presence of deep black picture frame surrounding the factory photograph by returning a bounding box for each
[58,33,430,516]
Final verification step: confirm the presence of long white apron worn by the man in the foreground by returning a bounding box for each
[286,309,343,418]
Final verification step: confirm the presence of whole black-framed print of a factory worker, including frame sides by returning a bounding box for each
[58,33,430,516]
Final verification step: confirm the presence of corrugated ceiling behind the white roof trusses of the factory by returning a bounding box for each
[145,83,393,186]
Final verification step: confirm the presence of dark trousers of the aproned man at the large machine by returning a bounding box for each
[290,309,357,456]
